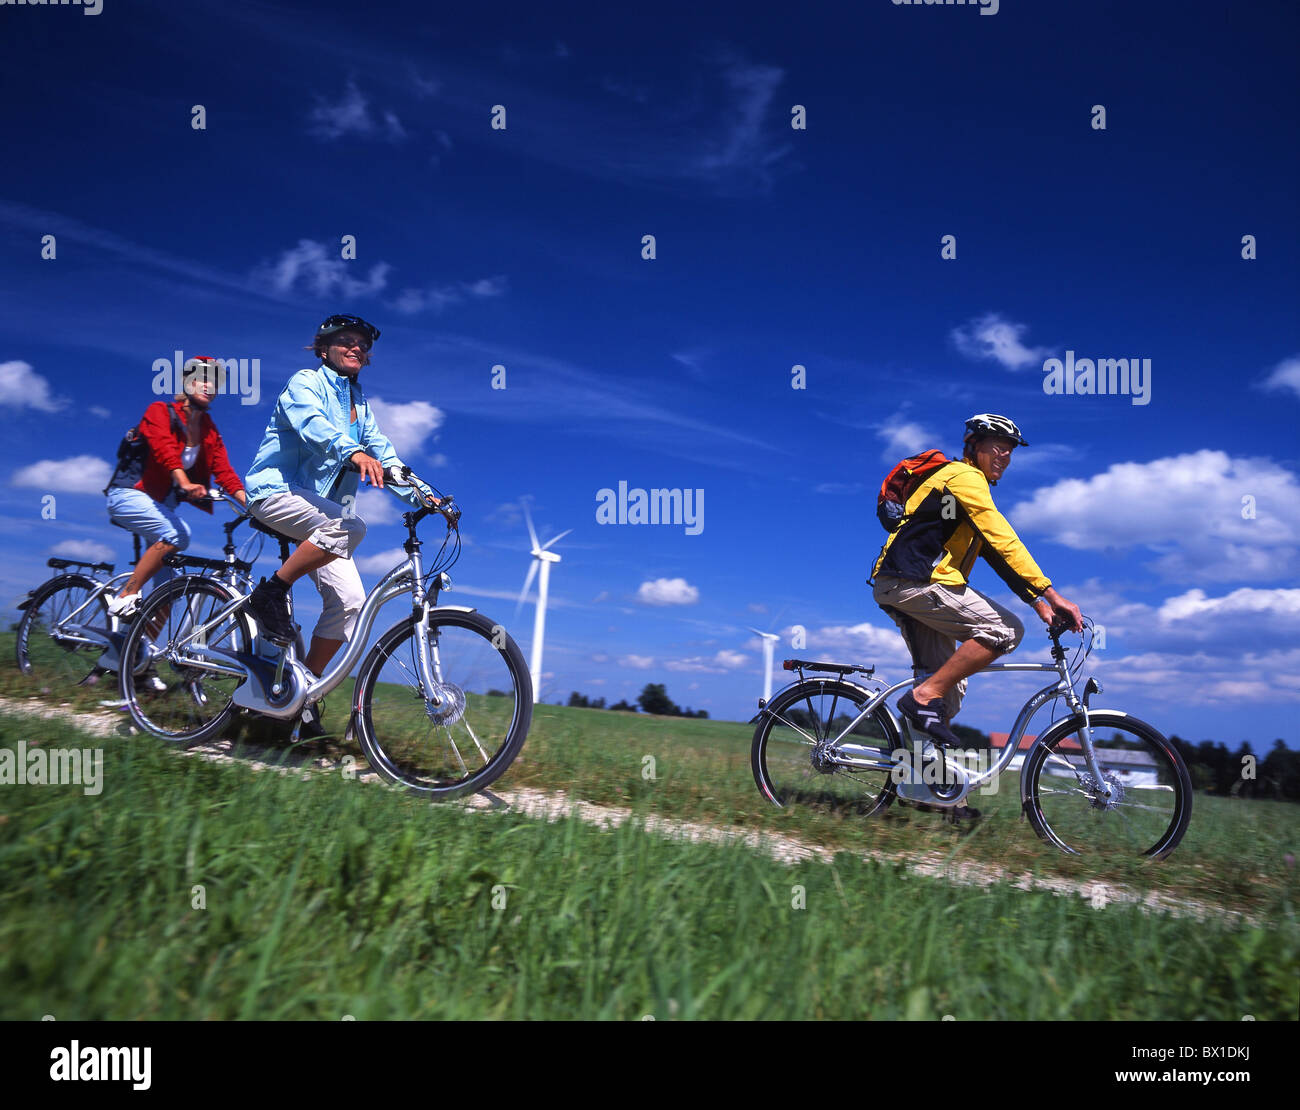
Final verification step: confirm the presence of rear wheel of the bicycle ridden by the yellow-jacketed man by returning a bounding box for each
[750,678,902,816]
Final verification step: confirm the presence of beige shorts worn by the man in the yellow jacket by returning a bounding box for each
[874,577,1024,717]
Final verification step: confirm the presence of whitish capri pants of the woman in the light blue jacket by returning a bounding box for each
[248,489,365,639]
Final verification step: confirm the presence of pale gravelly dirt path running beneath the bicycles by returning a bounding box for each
[0,697,1242,924]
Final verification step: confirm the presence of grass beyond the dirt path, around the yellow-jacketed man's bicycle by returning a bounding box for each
[501,706,1300,914]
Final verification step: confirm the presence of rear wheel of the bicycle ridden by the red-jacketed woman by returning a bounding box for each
[16,574,112,690]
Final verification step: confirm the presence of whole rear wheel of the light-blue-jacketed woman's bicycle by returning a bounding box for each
[120,574,255,745]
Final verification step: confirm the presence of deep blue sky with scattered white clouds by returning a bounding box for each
[0,0,1300,750]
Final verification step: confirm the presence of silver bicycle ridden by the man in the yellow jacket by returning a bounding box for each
[751,620,1192,859]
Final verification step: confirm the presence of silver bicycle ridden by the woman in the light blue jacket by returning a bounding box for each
[120,467,533,799]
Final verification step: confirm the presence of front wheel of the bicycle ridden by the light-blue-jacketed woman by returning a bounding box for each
[356,610,533,801]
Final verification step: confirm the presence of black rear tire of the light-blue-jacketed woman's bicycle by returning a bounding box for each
[118,574,256,746]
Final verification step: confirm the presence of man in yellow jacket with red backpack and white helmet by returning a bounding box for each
[871,412,1082,746]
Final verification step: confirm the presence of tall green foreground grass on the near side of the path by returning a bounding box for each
[0,711,1300,1020]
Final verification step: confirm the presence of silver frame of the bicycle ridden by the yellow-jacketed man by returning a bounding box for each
[772,645,1110,805]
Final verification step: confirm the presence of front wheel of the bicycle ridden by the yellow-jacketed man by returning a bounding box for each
[1022,710,1192,859]
